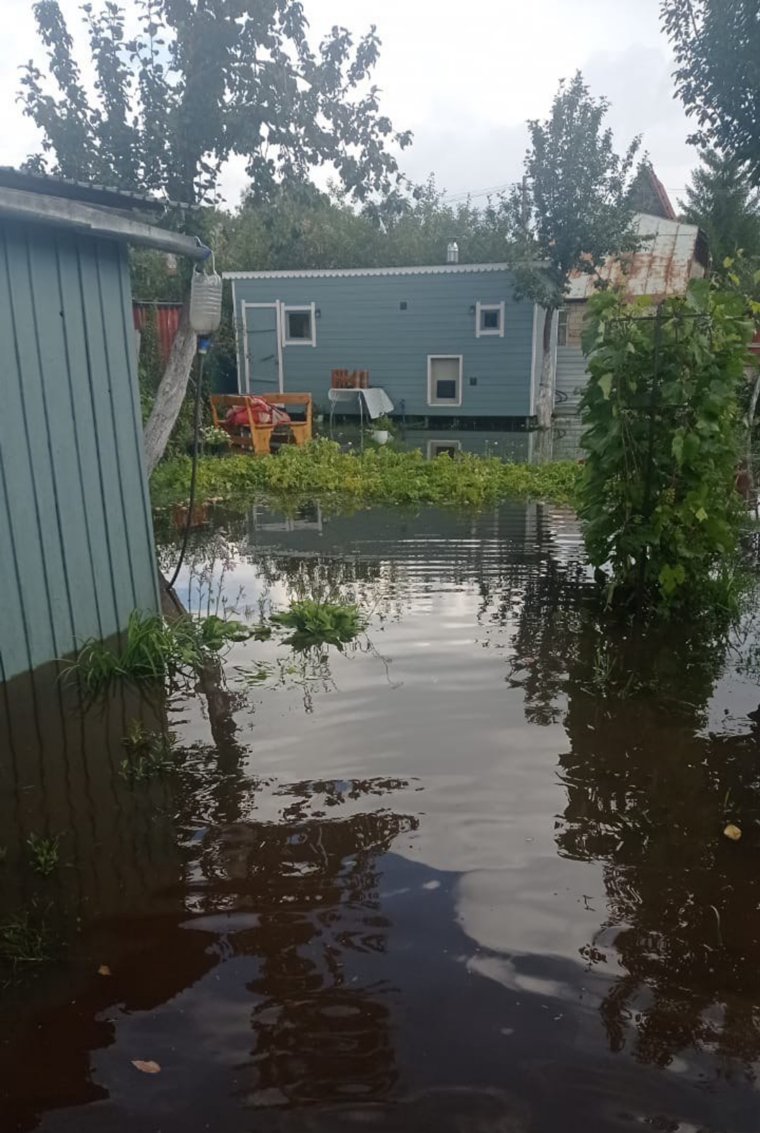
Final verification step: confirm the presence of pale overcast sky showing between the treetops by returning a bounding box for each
[0,0,695,203]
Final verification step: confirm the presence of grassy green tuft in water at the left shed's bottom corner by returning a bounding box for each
[66,611,250,693]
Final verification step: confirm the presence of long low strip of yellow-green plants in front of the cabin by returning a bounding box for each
[151,440,580,506]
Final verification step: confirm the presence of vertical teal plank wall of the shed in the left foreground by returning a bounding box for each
[0,222,159,680]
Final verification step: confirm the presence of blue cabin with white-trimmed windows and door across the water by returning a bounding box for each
[225,264,544,421]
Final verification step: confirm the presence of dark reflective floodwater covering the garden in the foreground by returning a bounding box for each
[0,504,760,1133]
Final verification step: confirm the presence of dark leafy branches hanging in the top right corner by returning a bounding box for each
[661,0,760,185]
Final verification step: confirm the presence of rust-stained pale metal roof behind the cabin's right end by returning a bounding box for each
[567,213,707,301]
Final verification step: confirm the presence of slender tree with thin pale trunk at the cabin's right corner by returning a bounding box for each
[511,71,639,428]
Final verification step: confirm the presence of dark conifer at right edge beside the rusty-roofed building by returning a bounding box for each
[680,150,760,271]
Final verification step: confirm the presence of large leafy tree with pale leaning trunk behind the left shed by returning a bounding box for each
[20,0,410,470]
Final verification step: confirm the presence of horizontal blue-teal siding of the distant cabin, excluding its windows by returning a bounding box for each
[229,271,533,417]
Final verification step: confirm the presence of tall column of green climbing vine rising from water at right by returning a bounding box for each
[580,280,752,607]
